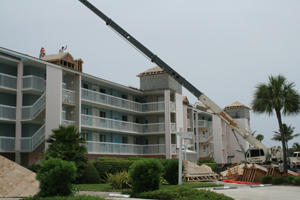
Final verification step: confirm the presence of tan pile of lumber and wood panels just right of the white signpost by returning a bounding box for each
[184,161,220,181]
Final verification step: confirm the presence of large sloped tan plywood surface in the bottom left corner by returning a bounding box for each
[0,156,39,198]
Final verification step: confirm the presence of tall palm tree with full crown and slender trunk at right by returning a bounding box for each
[251,75,300,173]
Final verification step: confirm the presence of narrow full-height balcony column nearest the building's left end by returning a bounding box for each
[15,62,24,164]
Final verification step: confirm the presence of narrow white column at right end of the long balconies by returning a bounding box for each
[164,90,172,159]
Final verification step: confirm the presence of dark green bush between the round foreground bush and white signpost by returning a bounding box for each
[160,159,184,185]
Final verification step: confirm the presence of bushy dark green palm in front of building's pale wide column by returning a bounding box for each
[44,126,88,178]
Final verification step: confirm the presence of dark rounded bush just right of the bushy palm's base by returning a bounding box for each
[76,162,100,184]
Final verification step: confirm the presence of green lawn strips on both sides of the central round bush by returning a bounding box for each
[74,182,223,192]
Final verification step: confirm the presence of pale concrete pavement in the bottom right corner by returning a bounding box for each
[207,183,300,200]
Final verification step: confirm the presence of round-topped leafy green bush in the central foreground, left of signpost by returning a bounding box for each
[129,159,163,193]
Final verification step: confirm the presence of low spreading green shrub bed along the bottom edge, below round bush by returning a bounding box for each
[132,187,233,200]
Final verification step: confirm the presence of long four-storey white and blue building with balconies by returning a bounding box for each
[0,48,249,166]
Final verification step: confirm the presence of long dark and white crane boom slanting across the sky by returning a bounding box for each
[79,0,267,152]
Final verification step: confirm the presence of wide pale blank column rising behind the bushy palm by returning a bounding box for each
[45,66,62,149]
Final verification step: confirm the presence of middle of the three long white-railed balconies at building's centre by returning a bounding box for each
[81,115,176,133]
